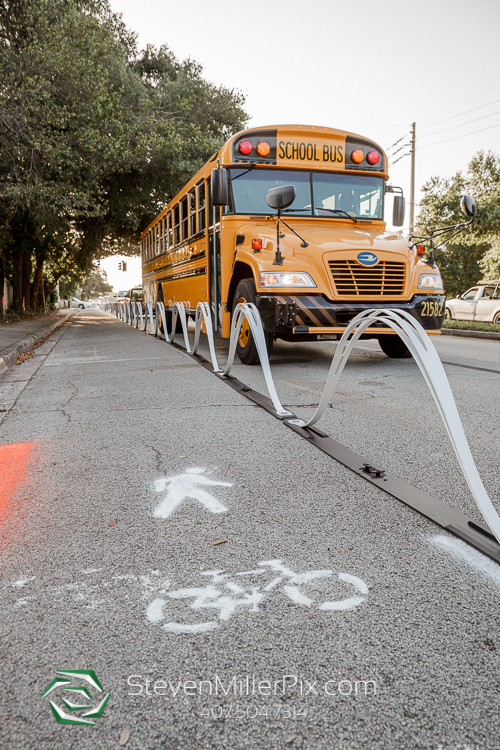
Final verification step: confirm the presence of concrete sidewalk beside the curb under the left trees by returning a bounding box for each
[0,310,77,376]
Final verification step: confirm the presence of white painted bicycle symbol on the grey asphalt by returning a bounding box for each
[146,560,368,633]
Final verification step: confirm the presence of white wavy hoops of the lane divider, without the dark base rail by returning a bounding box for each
[113,302,500,546]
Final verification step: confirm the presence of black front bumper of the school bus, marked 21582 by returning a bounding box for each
[257,294,446,339]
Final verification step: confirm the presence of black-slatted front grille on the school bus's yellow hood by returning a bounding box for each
[328,260,406,297]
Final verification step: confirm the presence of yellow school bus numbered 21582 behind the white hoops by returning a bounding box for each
[141,125,445,364]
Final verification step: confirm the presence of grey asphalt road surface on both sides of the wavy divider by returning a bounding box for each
[0,310,500,750]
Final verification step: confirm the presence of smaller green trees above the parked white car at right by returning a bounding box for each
[415,151,500,297]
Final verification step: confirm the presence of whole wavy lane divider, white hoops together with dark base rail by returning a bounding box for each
[110,302,500,563]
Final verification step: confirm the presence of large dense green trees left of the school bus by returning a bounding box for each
[0,0,247,311]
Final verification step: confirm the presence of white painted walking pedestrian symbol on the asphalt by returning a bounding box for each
[153,467,233,518]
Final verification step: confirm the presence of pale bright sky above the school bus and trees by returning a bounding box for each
[103,0,500,289]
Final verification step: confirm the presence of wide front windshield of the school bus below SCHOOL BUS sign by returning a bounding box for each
[229,169,384,219]
